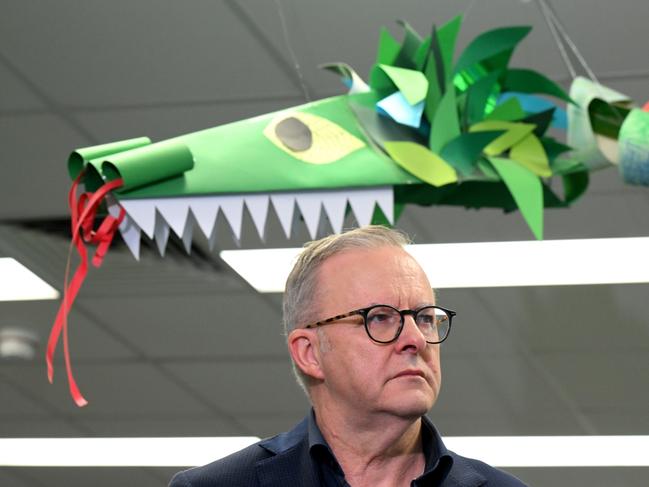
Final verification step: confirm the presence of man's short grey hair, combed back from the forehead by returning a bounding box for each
[283,225,411,396]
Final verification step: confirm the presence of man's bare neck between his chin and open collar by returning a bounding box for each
[316,407,426,487]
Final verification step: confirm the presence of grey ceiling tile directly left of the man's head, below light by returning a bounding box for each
[82,292,288,358]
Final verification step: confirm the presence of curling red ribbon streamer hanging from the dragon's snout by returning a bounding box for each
[45,172,126,407]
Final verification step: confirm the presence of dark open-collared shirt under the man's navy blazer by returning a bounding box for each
[308,410,453,487]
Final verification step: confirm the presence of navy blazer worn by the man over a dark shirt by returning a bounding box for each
[169,417,525,487]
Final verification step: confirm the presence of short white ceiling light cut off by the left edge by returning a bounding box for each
[0,257,59,301]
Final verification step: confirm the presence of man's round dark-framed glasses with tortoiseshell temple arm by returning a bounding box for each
[304,304,457,344]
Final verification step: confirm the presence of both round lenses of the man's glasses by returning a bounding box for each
[366,306,451,343]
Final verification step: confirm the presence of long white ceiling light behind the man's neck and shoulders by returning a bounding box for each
[0,436,649,467]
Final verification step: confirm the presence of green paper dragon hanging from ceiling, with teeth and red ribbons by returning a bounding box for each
[47,16,649,405]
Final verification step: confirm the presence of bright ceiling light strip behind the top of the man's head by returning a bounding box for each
[221,237,649,293]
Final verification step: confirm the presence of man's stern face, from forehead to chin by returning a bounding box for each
[315,247,441,424]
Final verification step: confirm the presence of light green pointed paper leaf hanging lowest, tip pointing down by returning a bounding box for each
[489,157,543,240]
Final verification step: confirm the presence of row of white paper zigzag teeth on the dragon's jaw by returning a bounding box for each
[114,186,394,259]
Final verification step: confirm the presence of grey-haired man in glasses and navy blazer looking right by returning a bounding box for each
[171,226,523,487]
